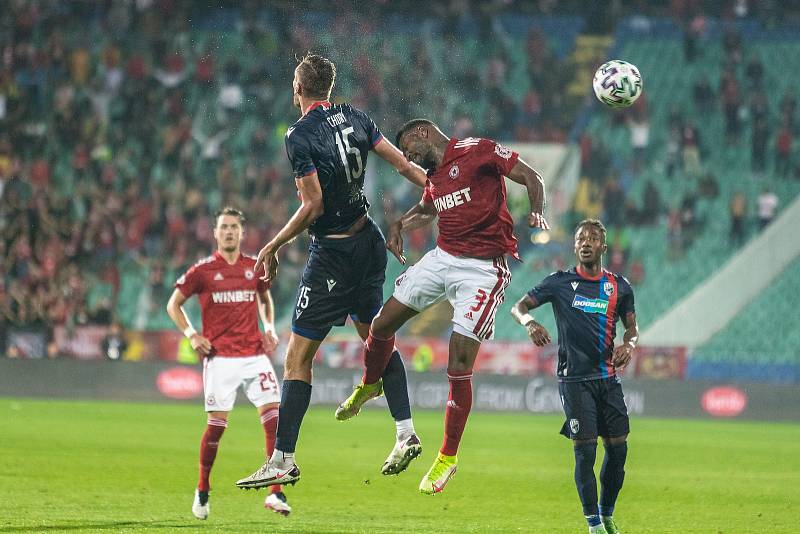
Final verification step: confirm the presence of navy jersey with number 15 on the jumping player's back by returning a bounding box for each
[286,102,383,237]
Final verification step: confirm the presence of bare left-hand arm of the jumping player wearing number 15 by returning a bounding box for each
[254,172,325,281]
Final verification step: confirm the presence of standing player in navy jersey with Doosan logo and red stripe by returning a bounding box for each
[511,219,639,534]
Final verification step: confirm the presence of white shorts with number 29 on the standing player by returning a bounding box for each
[203,354,281,412]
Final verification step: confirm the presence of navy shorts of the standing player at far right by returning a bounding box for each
[558,377,630,439]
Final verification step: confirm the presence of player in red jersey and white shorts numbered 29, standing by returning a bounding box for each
[167,208,292,519]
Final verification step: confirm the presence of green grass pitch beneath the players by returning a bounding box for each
[0,399,800,534]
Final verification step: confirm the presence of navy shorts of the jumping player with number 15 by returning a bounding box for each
[292,219,387,340]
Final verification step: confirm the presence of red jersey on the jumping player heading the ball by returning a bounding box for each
[422,137,519,259]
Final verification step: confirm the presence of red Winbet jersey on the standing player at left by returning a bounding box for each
[175,251,269,357]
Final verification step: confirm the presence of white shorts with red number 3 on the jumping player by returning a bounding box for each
[394,247,511,341]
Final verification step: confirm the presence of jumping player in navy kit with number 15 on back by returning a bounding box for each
[236,54,427,488]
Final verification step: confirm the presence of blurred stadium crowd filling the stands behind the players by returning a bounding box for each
[0,0,796,344]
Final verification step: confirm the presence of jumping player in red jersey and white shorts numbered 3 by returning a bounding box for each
[336,119,549,494]
